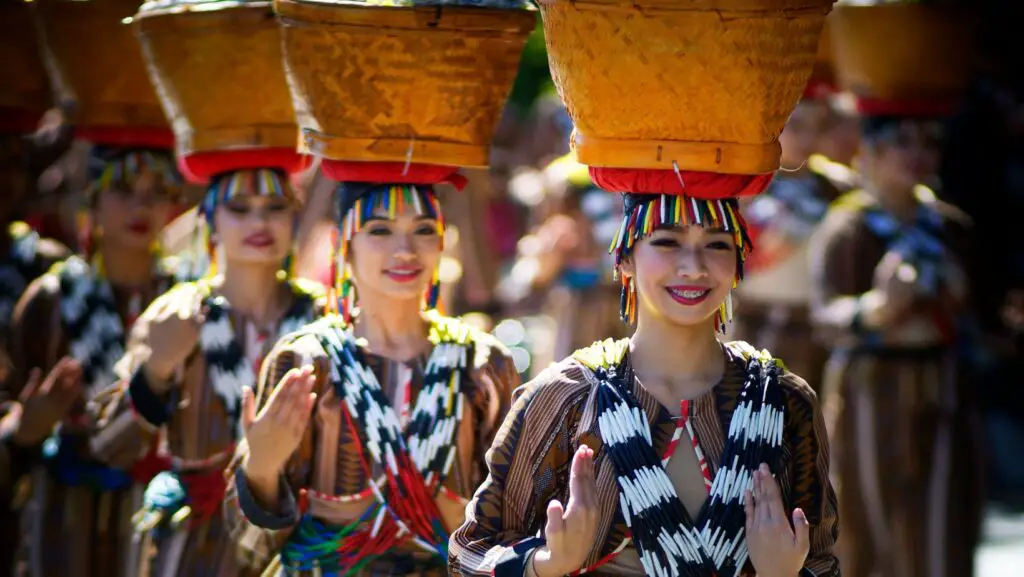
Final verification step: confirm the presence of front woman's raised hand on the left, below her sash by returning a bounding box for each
[534,445,598,577]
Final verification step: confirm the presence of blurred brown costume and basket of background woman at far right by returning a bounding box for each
[811,4,982,577]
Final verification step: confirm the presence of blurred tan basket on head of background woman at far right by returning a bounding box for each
[831,4,972,100]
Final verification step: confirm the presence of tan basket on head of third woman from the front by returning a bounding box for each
[135,2,298,154]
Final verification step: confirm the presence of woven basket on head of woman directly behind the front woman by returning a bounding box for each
[274,0,537,167]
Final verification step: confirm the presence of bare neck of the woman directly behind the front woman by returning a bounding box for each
[354,295,428,361]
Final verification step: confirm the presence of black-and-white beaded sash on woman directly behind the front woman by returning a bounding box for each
[314,315,472,498]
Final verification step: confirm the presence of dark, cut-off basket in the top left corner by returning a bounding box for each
[0,0,51,120]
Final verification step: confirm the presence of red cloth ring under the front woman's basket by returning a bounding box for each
[590,166,775,200]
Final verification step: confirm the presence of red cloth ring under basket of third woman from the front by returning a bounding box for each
[178,148,312,184]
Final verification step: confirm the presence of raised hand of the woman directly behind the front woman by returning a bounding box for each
[242,366,316,479]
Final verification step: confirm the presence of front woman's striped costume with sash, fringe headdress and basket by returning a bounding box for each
[450,0,839,576]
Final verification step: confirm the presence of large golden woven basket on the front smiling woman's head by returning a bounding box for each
[541,0,833,174]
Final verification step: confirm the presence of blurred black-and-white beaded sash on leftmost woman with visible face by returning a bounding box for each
[57,256,125,396]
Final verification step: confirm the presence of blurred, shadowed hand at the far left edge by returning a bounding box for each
[14,357,82,447]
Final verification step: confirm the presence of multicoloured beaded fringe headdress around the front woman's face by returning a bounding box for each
[608,195,753,331]
